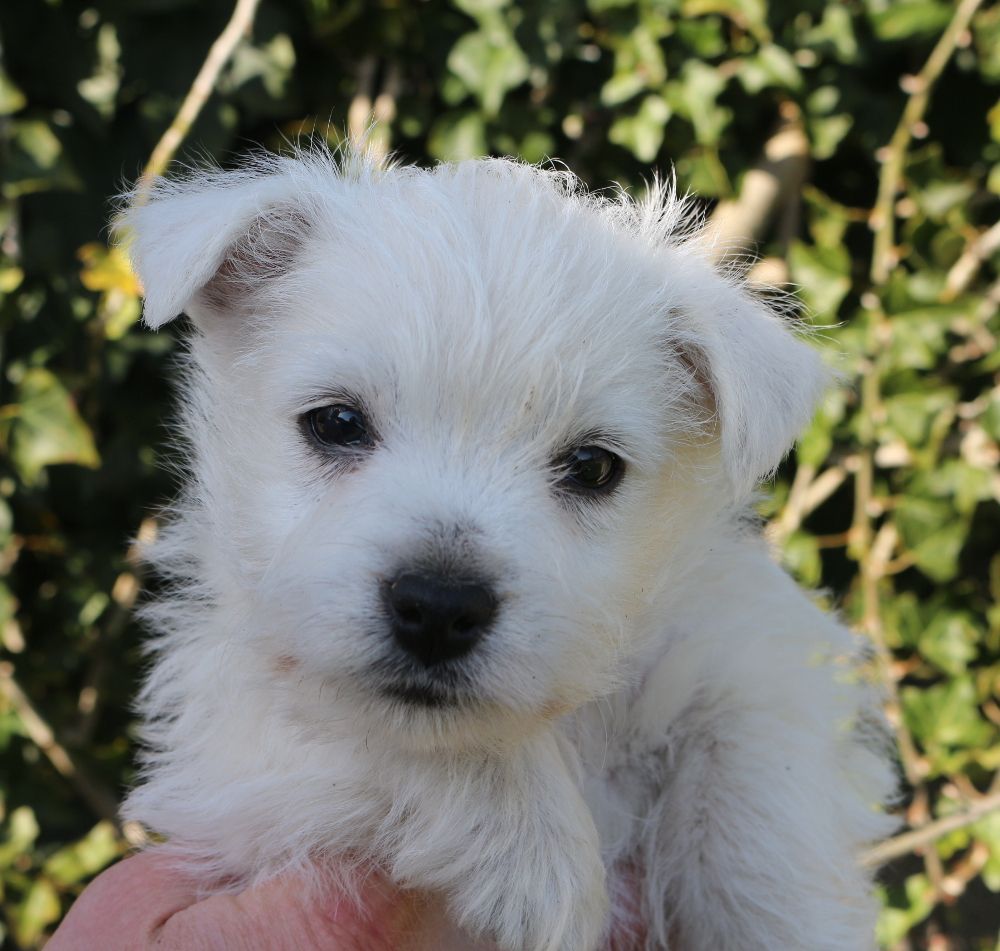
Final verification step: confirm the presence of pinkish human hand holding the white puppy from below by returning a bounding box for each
[46,850,490,951]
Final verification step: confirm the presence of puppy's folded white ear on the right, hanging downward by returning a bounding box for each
[674,252,831,496]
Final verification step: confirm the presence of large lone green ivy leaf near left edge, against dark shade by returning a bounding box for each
[11,367,101,484]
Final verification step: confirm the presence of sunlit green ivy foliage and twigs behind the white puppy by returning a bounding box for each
[0,0,1000,951]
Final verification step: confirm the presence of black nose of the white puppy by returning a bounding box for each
[384,574,497,667]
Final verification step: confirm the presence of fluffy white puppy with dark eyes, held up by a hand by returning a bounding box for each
[123,153,892,951]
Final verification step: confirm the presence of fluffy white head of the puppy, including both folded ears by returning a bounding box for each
[117,154,823,742]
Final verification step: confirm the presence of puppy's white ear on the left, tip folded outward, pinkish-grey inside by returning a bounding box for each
[114,165,309,330]
